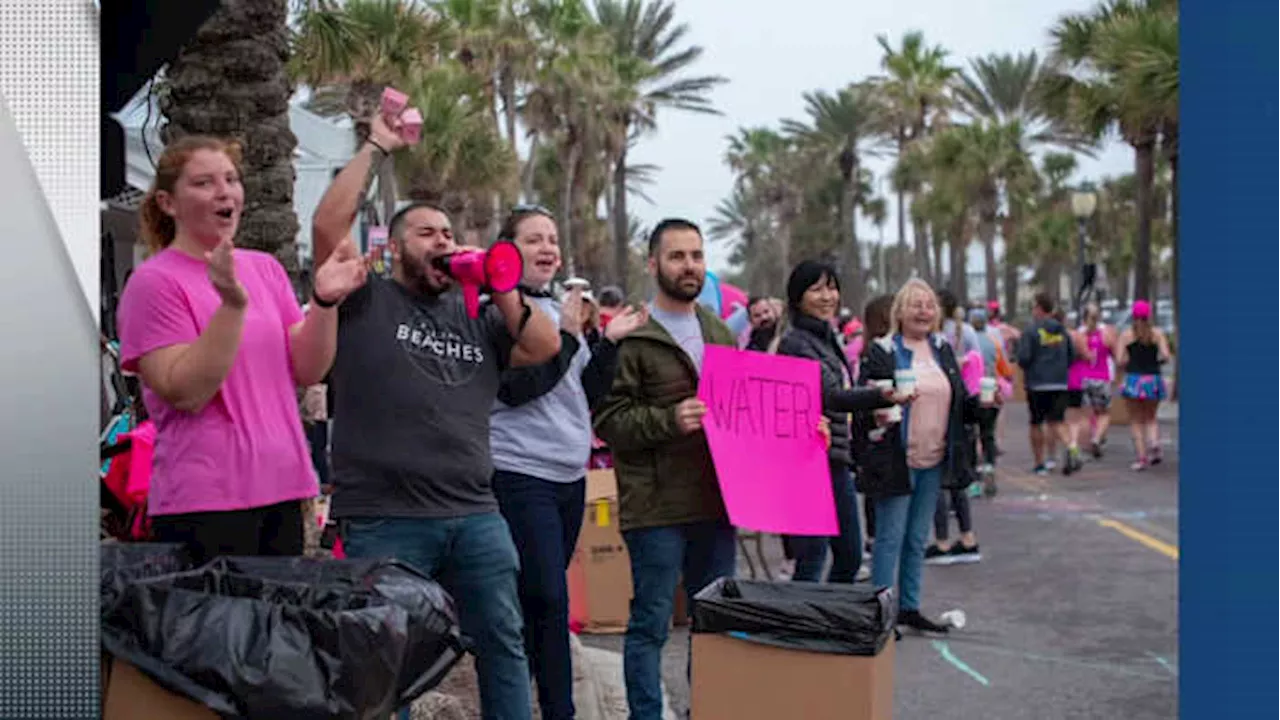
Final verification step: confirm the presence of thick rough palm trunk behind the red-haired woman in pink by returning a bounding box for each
[160,0,298,281]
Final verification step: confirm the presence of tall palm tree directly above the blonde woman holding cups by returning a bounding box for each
[874,31,957,278]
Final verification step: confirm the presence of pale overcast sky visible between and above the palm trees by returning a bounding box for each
[631,0,1133,270]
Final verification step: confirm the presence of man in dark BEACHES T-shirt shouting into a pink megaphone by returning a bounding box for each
[312,102,561,720]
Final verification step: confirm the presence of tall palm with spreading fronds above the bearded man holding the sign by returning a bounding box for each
[595,0,727,290]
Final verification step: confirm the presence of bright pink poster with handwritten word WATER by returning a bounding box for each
[698,345,840,536]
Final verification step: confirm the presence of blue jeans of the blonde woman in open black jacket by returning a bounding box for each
[872,465,942,610]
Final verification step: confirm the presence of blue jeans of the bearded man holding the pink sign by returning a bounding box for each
[622,521,737,720]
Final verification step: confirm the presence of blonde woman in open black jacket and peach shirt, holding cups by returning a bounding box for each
[854,279,1000,633]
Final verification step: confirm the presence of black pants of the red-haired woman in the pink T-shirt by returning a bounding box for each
[151,500,303,565]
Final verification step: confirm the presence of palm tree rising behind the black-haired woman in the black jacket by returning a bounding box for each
[782,83,884,306]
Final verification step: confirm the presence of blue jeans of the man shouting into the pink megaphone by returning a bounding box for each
[342,512,532,720]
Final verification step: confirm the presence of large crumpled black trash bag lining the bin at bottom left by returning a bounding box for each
[101,557,463,720]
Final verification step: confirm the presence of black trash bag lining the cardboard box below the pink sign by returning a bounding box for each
[692,578,897,656]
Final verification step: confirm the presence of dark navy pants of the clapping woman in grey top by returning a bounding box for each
[493,470,586,720]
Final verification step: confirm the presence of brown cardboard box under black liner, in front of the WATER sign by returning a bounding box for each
[690,633,895,720]
